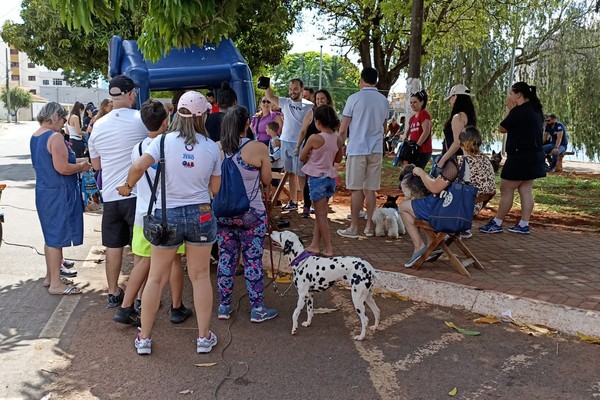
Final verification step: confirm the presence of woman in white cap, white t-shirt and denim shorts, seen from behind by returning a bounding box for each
[117,91,221,354]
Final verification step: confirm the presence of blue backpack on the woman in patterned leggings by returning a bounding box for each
[213,140,260,217]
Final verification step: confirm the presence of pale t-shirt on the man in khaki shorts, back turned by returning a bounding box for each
[343,86,390,156]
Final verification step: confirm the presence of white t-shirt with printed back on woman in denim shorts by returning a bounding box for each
[146,132,221,209]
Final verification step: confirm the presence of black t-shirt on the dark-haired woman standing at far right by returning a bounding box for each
[500,102,544,154]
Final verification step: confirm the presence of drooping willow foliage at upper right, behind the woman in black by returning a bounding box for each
[423,1,600,159]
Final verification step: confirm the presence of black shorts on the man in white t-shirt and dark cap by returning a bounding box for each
[102,197,136,248]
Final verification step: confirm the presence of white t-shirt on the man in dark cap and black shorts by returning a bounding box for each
[88,108,148,202]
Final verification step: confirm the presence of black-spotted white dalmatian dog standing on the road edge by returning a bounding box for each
[271,231,380,340]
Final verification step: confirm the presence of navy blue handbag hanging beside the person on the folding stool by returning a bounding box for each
[429,158,477,233]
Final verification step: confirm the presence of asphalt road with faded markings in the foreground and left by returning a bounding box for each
[0,124,600,400]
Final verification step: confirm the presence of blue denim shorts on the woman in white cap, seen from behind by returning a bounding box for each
[154,204,217,249]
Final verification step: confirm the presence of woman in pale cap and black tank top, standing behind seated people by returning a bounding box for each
[435,84,477,170]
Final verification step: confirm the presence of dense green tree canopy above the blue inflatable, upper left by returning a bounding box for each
[2,0,297,85]
